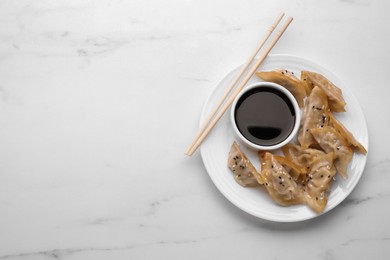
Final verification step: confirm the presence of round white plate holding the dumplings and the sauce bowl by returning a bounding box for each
[200,55,368,222]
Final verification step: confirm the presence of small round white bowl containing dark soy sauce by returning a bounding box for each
[230,82,301,150]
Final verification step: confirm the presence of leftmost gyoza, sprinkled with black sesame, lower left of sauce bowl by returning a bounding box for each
[228,142,263,187]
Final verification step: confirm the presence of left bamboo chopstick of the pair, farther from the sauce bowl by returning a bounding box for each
[186,13,284,155]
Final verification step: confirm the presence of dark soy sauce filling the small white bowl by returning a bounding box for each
[234,87,296,146]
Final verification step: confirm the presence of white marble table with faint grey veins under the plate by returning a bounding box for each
[0,0,390,260]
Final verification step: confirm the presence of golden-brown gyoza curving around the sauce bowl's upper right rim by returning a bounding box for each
[256,69,306,107]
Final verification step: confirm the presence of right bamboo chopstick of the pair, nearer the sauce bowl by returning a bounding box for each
[186,17,293,156]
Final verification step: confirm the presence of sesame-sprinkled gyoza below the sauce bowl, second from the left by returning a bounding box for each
[261,152,304,206]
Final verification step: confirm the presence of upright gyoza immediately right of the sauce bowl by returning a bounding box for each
[298,86,329,148]
